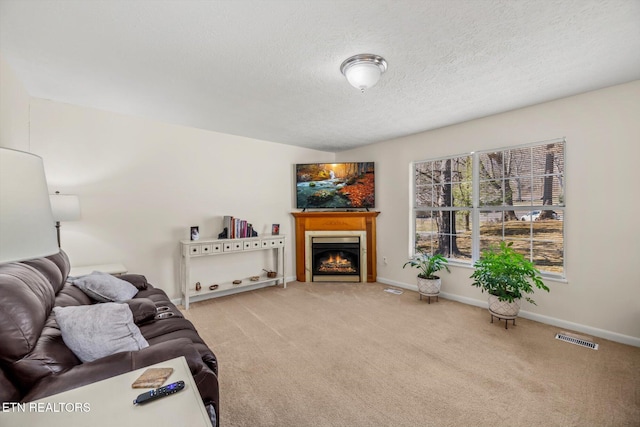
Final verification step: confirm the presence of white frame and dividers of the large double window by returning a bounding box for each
[408,137,567,280]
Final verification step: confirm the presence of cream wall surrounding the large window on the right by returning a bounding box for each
[336,81,640,345]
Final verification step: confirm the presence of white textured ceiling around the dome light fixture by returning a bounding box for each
[0,0,640,151]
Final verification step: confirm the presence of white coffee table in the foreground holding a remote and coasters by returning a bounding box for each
[0,357,211,427]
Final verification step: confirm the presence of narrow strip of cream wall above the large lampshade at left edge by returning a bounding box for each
[0,56,30,151]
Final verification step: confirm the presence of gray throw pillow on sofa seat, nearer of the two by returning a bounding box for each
[53,303,149,362]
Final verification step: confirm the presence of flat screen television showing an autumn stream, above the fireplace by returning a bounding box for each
[296,162,375,209]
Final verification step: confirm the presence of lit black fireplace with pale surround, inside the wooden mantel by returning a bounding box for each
[311,236,360,282]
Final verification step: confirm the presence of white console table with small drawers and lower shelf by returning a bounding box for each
[180,236,287,310]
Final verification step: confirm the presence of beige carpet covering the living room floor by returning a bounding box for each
[183,282,640,427]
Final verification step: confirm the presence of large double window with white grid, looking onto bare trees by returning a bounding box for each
[413,139,565,277]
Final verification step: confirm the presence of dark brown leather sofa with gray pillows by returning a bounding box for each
[0,251,220,426]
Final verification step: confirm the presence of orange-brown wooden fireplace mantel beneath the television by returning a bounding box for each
[291,211,380,282]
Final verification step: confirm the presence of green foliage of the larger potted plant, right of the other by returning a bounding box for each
[471,241,549,304]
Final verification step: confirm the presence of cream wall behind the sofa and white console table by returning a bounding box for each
[31,99,335,298]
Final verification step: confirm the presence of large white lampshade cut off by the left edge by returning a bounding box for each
[0,148,59,264]
